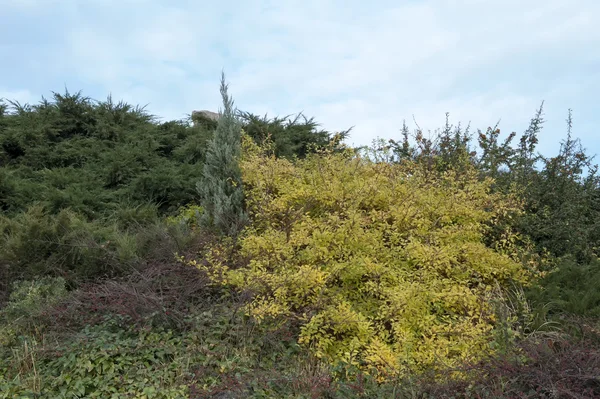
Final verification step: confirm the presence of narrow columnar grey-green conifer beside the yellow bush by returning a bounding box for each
[196,73,248,236]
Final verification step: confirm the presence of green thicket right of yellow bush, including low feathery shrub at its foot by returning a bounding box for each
[380,108,600,316]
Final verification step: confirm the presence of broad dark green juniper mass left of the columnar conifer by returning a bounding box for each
[0,92,211,219]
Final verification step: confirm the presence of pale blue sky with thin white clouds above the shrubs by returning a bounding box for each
[0,0,600,155]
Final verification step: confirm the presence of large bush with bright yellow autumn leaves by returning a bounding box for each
[191,137,527,382]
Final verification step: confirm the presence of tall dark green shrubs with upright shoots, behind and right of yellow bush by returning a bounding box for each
[389,108,600,268]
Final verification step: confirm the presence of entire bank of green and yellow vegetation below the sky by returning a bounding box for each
[0,77,600,398]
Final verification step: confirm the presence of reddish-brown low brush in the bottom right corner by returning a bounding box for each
[421,337,600,399]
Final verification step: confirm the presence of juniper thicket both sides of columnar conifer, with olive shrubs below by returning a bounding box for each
[0,86,338,303]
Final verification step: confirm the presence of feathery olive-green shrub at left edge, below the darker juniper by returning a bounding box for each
[0,206,137,281]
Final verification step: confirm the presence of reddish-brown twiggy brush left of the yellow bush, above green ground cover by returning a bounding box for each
[37,247,218,332]
